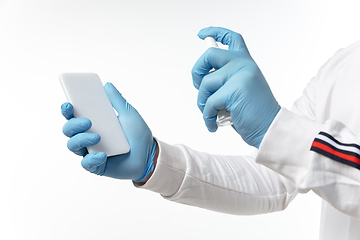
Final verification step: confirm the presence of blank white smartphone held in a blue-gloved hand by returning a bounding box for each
[60,73,130,156]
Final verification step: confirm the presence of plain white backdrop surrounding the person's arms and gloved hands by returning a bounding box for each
[0,0,360,239]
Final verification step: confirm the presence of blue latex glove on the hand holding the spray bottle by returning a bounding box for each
[192,27,280,148]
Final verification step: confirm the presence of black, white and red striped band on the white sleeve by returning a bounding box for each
[310,132,360,170]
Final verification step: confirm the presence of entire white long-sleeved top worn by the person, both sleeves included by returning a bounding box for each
[141,41,360,240]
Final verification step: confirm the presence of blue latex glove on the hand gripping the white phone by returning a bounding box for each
[61,83,156,182]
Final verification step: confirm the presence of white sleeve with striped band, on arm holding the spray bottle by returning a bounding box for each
[256,42,360,219]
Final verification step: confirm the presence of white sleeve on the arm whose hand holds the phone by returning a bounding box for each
[140,141,297,215]
